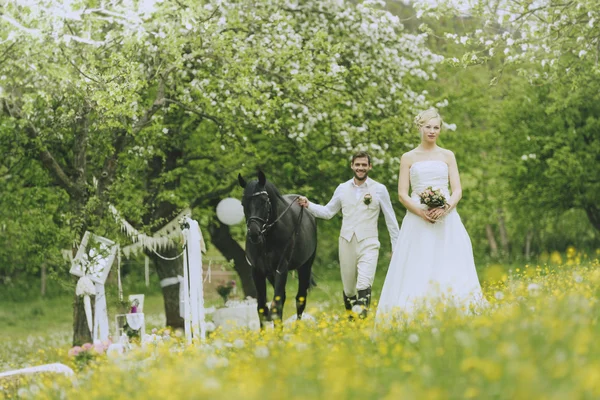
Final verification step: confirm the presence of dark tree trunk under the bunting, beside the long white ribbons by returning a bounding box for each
[147,249,184,329]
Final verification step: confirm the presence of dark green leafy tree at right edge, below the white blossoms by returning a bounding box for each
[503,65,600,230]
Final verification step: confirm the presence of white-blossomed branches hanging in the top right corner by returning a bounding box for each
[417,0,600,83]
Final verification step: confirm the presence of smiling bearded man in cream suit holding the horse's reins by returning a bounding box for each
[298,151,399,318]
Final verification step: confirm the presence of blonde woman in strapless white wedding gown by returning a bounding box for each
[376,109,484,321]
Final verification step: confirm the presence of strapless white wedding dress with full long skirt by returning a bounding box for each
[376,160,485,322]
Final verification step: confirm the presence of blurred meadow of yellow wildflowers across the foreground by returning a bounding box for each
[4,255,600,400]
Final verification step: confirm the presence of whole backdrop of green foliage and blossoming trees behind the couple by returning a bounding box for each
[0,0,600,288]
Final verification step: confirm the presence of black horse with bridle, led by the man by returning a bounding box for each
[238,171,317,326]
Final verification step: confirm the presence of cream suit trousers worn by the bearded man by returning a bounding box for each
[339,235,380,297]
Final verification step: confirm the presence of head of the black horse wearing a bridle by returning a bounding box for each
[238,171,271,244]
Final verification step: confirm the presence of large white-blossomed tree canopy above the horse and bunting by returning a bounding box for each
[0,0,441,343]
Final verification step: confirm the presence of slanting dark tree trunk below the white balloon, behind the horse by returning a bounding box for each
[208,218,256,298]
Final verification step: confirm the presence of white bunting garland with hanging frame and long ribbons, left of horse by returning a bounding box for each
[63,205,210,343]
